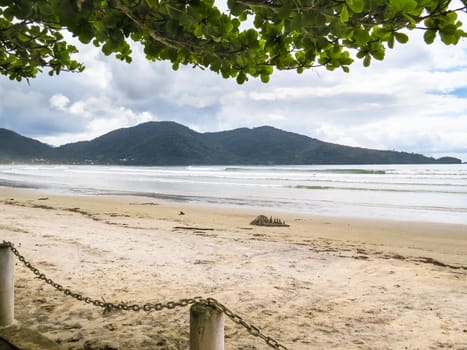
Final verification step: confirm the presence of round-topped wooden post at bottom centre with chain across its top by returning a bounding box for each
[190,304,224,350]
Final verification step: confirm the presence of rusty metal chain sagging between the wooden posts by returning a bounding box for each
[0,241,288,350]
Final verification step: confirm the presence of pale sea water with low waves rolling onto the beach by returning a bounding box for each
[0,164,467,224]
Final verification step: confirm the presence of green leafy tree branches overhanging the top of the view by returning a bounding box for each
[0,0,467,83]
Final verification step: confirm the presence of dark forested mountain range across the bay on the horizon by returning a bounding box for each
[0,122,460,165]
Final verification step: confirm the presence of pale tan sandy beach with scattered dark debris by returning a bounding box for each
[0,188,467,350]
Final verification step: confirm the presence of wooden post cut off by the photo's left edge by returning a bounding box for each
[0,243,15,327]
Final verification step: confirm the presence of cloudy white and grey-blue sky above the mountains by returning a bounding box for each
[0,9,467,161]
